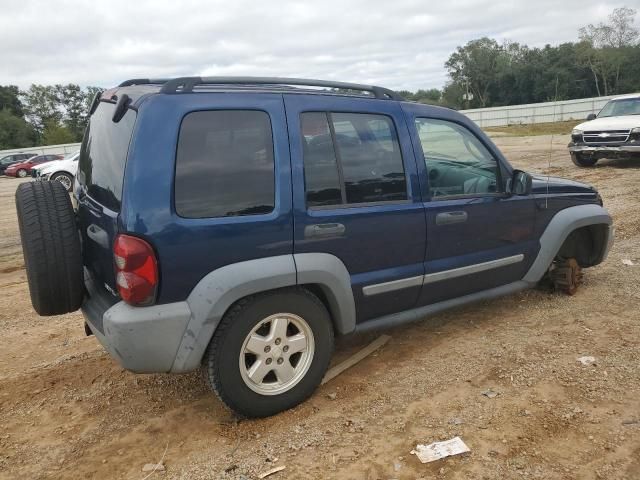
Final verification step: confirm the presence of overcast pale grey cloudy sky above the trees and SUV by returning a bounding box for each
[0,0,640,91]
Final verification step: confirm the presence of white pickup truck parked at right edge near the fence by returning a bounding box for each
[569,93,640,167]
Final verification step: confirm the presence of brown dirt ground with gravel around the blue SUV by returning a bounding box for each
[0,136,640,480]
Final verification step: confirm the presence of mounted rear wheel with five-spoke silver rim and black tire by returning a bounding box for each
[203,288,333,417]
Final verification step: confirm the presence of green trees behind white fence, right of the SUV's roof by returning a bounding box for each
[399,7,640,108]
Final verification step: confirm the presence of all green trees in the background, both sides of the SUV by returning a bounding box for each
[0,7,640,150]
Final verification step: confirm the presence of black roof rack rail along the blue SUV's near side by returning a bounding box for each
[158,77,404,101]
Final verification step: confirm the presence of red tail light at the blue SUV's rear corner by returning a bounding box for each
[113,235,158,306]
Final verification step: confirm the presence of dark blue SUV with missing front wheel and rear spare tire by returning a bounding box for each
[16,77,613,417]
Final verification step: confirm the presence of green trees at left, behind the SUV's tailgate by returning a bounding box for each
[0,83,102,150]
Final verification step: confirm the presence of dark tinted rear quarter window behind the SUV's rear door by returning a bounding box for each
[175,110,275,218]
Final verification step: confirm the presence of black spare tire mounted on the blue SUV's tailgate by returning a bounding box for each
[16,182,84,316]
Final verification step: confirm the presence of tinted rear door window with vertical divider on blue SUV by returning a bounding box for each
[301,112,407,207]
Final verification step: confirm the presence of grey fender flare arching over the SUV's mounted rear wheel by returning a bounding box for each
[171,253,355,373]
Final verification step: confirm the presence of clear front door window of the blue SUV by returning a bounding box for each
[416,118,499,198]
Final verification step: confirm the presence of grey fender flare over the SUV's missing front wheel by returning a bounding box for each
[523,204,613,284]
